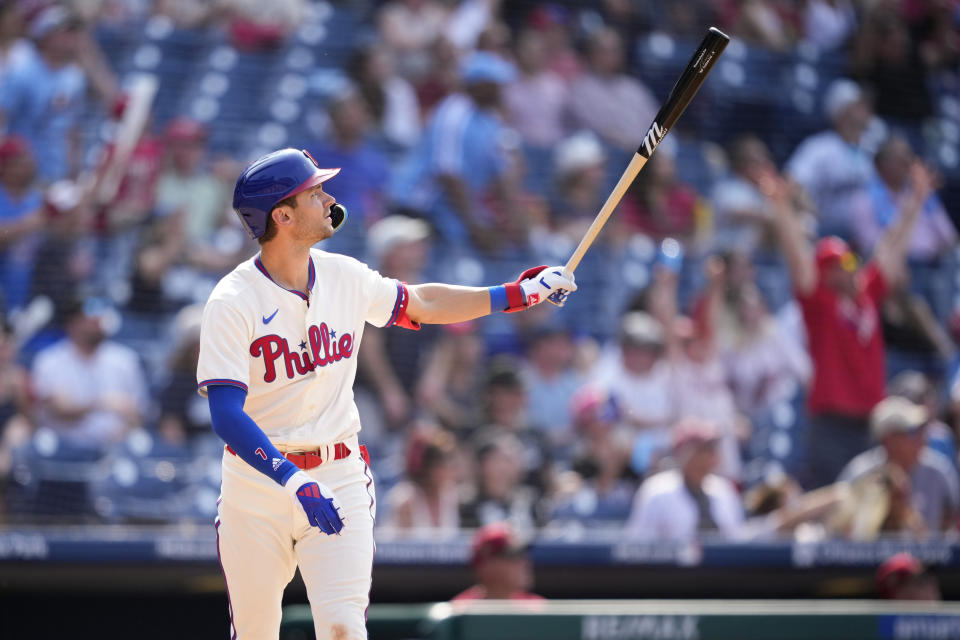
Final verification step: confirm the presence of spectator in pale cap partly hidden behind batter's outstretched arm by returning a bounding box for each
[358,215,438,428]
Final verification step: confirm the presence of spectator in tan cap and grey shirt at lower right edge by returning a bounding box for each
[839,396,960,531]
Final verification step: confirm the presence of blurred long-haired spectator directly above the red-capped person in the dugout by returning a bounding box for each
[460,433,542,535]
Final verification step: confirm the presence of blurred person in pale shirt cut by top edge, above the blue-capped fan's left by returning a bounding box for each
[378,0,450,80]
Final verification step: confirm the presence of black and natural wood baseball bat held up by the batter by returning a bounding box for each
[565,27,730,274]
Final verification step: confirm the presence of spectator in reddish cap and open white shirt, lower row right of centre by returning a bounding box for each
[624,419,744,542]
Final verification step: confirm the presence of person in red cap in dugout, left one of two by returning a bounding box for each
[452,522,543,602]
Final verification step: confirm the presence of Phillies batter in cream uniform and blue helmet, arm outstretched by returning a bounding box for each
[197,149,577,640]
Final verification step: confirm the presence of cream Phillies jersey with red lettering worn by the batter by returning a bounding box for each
[197,249,407,451]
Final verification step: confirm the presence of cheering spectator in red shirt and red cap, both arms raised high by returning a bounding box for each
[761,162,933,488]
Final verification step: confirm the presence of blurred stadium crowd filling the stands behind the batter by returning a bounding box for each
[0,0,960,540]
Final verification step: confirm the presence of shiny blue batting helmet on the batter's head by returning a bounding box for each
[233,148,346,239]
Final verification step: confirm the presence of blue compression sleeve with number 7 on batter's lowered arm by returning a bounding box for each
[207,384,297,485]
